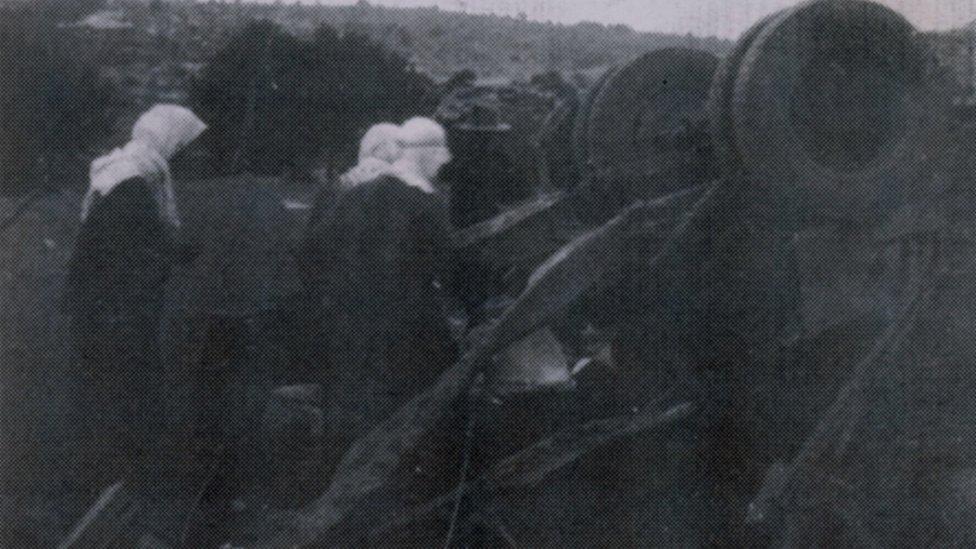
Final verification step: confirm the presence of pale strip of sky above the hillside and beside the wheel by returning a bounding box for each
[240,0,976,38]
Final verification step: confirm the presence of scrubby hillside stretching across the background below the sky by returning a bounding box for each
[0,0,730,180]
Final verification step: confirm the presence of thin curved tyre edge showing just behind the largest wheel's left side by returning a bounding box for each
[707,12,781,175]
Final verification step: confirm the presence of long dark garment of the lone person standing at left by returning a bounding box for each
[63,178,183,489]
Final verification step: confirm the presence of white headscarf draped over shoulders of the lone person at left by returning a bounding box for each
[81,105,207,227]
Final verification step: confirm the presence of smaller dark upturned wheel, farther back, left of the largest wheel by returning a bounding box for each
[588,48,718,171]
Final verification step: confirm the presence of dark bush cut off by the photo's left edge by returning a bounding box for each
[0,10,116,194]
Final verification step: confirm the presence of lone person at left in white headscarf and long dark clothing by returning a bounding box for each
[64,105,207,484]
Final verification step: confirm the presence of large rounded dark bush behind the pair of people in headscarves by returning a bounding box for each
[190,21,432,175]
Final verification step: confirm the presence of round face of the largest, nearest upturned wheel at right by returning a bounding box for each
[733,0,941,221]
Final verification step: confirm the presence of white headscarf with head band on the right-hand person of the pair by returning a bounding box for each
[392,117,451,193]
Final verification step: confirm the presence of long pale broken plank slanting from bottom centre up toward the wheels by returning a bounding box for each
[256,181,725,547]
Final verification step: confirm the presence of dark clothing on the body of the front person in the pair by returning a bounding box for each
[311,176,455,450]
